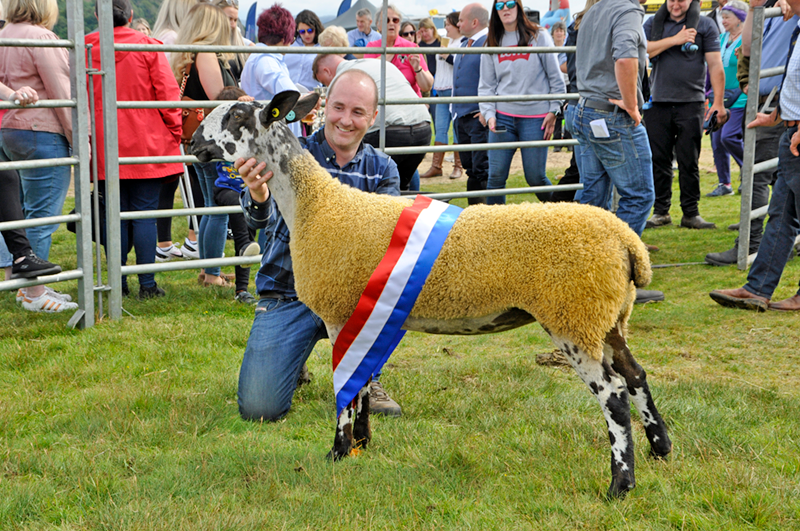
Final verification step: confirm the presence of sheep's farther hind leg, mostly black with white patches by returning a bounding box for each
[606,325,672,459]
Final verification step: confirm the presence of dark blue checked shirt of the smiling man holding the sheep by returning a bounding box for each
[239,130,400,297]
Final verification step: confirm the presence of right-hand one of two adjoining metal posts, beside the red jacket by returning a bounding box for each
[97,0,122,319]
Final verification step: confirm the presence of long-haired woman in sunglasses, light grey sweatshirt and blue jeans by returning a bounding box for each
[478,0,567,205]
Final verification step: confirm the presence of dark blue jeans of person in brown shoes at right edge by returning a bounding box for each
[744,126,800,299]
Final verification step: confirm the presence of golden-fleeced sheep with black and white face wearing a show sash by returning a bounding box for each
[191,92,672,497]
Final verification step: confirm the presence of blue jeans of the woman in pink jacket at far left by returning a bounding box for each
[2,129,70,260]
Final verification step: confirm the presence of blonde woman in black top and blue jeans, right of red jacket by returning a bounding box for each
[170,3,236,287]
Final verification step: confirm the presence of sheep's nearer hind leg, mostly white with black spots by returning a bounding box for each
[552,336,636,498]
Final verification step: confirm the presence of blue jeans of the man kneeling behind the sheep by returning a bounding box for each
[238,299,328,420]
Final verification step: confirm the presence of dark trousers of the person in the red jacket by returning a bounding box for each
[98,179,164,288]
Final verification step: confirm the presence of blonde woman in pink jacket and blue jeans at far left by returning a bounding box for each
[0,0,76,312]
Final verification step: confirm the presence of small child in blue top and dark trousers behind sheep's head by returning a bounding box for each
[214,87,261,304]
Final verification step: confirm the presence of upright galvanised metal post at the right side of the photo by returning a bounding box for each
[736,7,764,270]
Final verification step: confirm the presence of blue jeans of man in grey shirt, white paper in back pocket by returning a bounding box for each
[570,105,656,236]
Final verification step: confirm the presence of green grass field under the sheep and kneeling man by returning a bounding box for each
[0,152,800,531]
